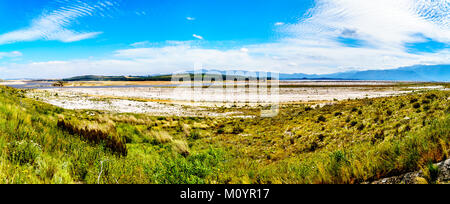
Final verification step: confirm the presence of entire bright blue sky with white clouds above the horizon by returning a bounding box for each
[0,0,450,79]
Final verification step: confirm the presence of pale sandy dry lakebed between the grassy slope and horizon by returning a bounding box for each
[23,81,444,117]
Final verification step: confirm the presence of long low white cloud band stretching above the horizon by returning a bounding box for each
[0,40,450,78]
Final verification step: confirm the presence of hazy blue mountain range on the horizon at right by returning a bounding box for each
[280,65,450,82]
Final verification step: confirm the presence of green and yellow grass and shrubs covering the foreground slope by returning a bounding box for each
[0,87,450,184]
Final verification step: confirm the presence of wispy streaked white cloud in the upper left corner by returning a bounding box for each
[0,0,116,44]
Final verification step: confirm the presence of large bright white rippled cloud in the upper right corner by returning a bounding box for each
[287,0,450,49]
